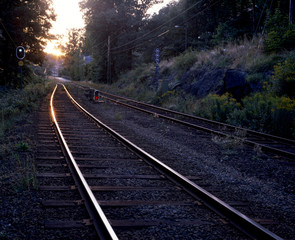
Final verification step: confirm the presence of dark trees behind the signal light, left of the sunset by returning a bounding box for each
[0,0,55,86]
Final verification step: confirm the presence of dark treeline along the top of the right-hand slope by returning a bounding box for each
[60,0,295,82]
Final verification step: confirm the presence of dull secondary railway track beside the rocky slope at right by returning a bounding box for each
[93,87,295,162]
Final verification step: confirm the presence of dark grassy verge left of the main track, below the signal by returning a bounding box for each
[0,79,53,192]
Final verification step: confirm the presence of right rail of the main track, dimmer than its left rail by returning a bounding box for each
[63,85,282,240]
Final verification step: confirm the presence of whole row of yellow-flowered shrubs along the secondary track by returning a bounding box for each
[190,92,295,138]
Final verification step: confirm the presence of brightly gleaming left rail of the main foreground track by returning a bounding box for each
[50,85,118,240]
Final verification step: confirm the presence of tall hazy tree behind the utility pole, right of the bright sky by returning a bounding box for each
[81,0,160,81]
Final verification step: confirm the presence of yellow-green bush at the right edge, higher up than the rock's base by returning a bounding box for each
[271,52,295,99]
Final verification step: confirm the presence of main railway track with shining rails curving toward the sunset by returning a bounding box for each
[39,83,286,239]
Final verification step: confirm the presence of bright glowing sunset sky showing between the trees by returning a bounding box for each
[45,0,174,56]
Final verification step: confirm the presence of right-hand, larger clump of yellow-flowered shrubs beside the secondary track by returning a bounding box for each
[227,92,295,137]
